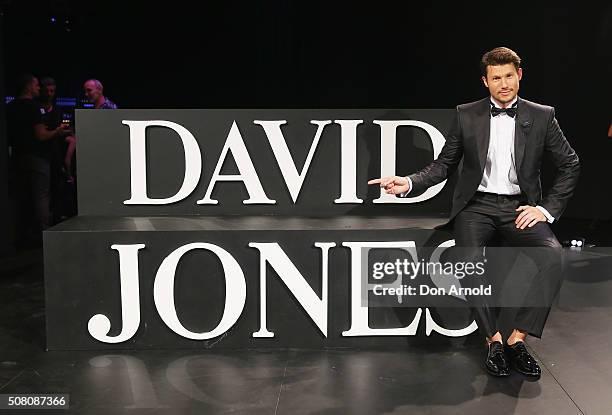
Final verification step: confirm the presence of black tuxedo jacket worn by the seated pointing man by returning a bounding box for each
[408,97,580,221]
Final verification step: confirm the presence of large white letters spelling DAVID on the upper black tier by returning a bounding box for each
[122,120,446,205]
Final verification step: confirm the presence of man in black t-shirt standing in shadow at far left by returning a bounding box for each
[6,75,69,245]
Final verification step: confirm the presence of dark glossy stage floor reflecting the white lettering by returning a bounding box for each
[0,248,612,415]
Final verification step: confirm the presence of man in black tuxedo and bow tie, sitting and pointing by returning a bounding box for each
[368,47,580,377]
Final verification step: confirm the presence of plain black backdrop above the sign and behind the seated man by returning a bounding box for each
[0,0,612,237]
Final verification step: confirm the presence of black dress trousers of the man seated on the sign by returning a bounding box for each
[453,192,563,337]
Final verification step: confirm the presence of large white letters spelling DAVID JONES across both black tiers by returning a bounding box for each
[83,115,476,343]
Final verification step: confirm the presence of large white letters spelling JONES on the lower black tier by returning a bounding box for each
[88,241,476,343]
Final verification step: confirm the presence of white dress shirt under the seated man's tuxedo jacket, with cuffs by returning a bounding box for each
[400,97,555,223]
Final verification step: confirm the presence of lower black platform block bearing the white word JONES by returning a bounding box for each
[44,216,482,349]
